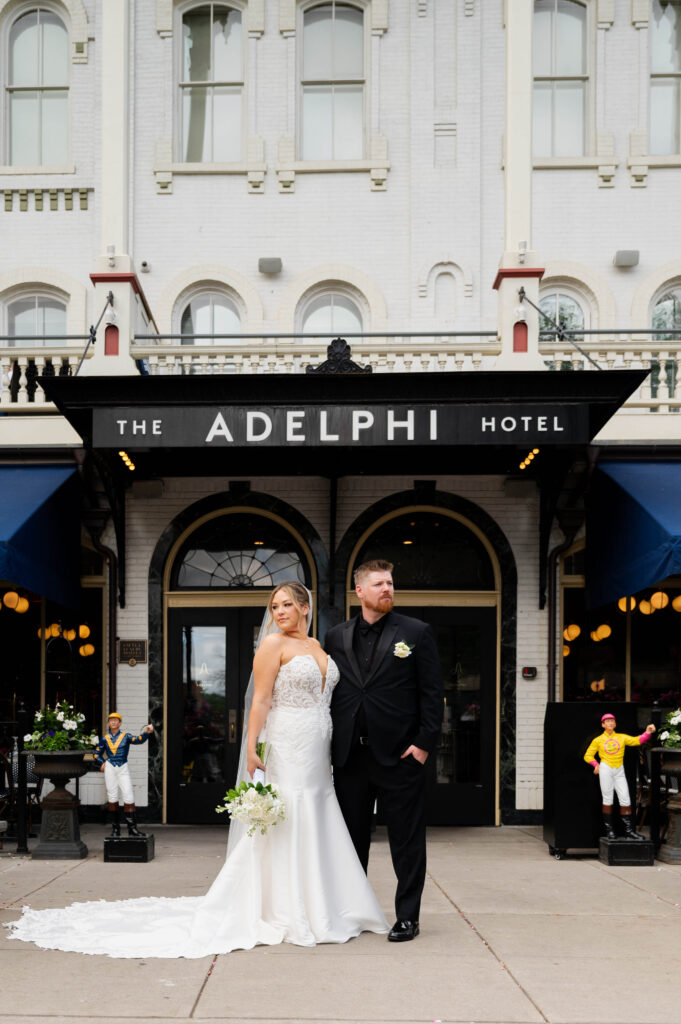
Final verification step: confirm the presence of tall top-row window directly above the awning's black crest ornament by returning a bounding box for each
[300,0,366,160]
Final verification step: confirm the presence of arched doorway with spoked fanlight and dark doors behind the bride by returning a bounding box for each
[163,507,316,823]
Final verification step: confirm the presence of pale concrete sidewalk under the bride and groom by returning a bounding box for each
[0,825,681,1024]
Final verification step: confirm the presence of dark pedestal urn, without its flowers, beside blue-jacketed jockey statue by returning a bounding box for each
[31,751,87,860]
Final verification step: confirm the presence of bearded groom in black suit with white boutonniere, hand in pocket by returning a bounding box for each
[327,559,442,942]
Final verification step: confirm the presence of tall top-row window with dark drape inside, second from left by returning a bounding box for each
[179,3,244,164]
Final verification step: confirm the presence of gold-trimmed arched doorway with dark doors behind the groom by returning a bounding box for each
[346,505,502,825]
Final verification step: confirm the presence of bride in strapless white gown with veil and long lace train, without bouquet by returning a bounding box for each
[7,581,388,958]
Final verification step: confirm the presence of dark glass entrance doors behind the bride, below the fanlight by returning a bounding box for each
[167,607,263,824]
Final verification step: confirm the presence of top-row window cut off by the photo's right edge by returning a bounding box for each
[650,0,681,156]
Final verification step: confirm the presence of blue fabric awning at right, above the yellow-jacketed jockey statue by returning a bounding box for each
[586,461,681,607]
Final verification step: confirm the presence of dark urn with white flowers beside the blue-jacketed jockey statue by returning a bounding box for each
[24,700,98,860]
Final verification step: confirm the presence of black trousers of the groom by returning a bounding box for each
[334,743,426,921]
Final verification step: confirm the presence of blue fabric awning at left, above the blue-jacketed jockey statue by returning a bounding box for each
[0,466,80,608]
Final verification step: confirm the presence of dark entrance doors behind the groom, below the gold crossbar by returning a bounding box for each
[395,601,497,825]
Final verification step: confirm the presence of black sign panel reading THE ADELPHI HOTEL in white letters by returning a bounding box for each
[93,403,589,450]
